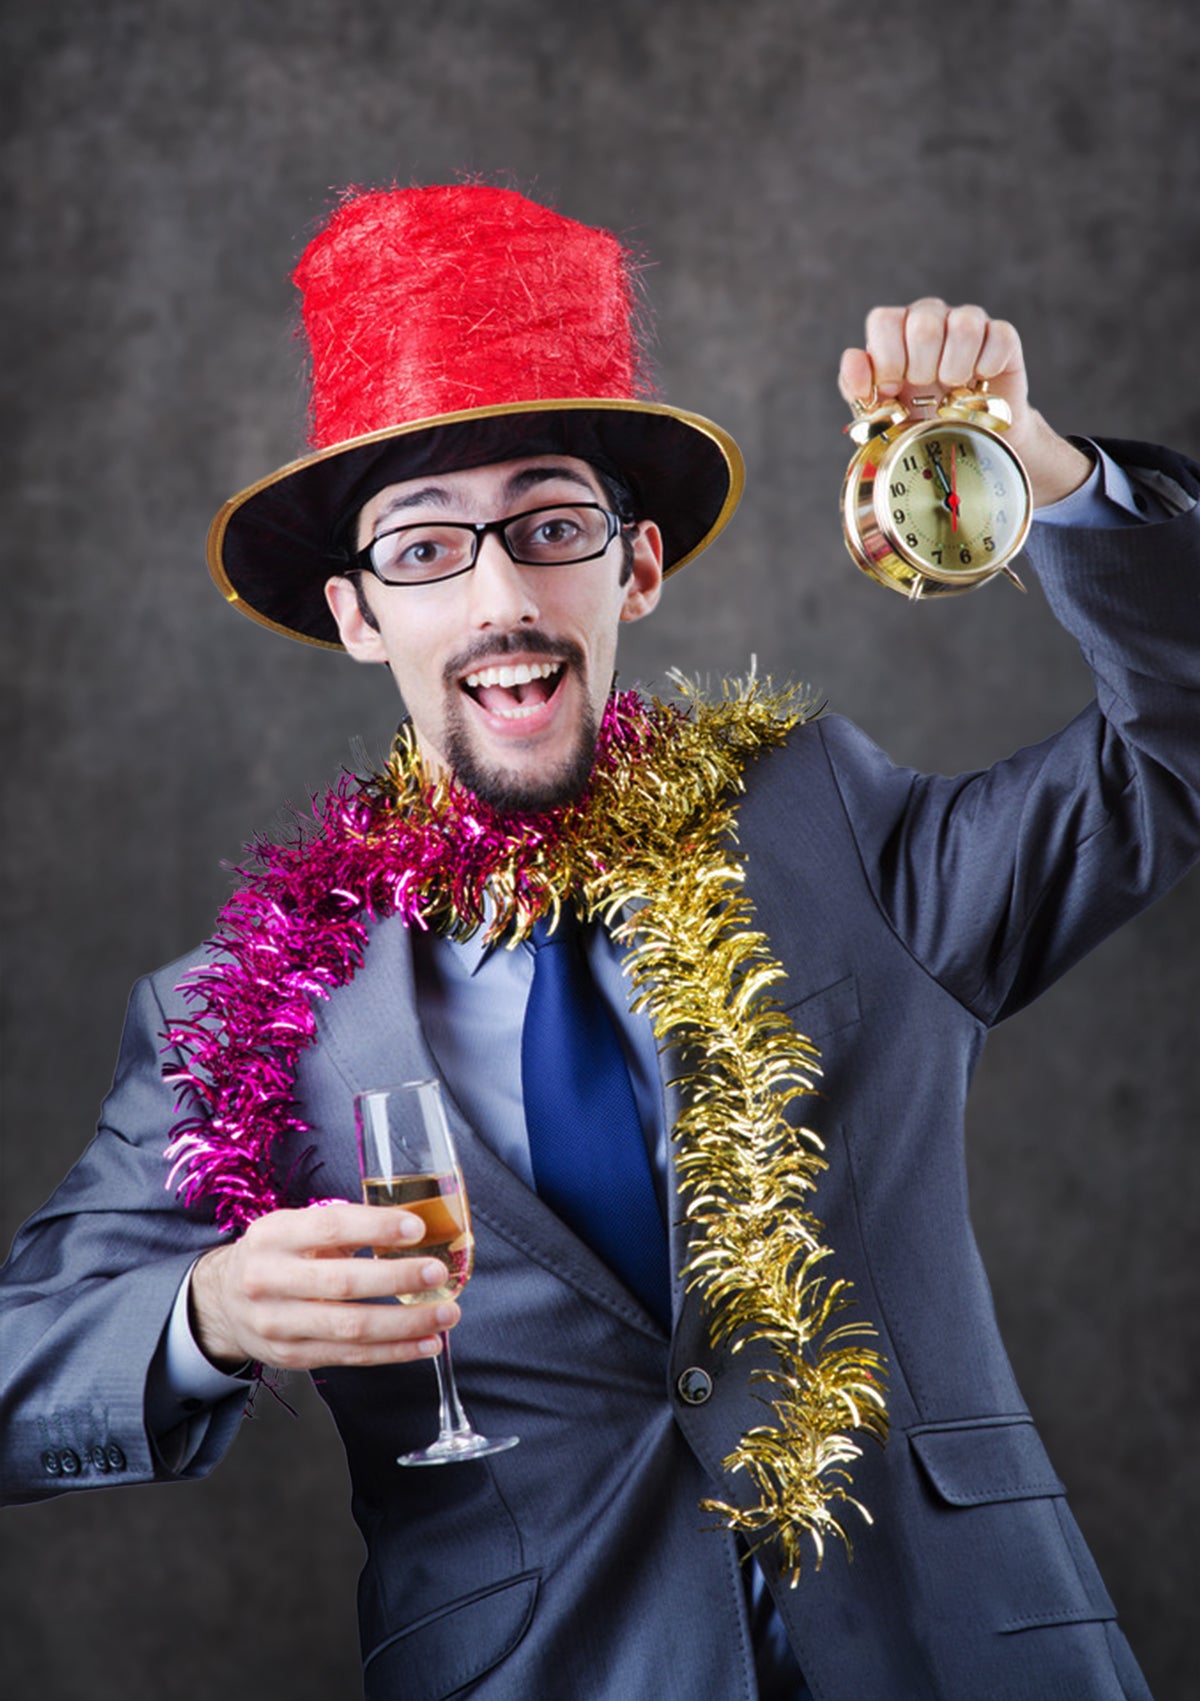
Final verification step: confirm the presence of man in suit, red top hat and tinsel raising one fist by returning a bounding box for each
[5,187,1200,1701]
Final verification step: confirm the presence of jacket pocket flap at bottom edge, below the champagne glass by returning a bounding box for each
[363,1572,540,1701]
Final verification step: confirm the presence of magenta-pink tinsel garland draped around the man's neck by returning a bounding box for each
[163,692,653,1230]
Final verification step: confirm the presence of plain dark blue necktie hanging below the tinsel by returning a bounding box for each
[521,910,671,1328]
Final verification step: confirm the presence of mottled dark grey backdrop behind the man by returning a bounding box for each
[0,0,1200,1701]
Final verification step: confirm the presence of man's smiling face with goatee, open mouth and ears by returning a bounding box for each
[325,456,662,811]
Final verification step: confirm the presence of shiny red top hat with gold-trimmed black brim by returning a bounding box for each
[208,184,742,650]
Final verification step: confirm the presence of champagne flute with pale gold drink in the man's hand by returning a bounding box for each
[354,1080,519,1465]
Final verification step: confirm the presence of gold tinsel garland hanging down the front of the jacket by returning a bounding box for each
[381,679,887,1585]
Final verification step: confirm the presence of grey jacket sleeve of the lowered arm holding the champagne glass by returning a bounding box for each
[0,971,243,1504]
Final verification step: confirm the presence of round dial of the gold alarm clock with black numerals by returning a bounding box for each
[873,420,1031,583]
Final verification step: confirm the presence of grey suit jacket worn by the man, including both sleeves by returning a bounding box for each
[5,446,1200,1701]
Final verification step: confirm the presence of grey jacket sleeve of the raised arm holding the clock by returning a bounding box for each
[826,442,1200,1024]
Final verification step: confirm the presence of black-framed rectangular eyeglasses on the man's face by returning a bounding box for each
[351,502,625,585]
